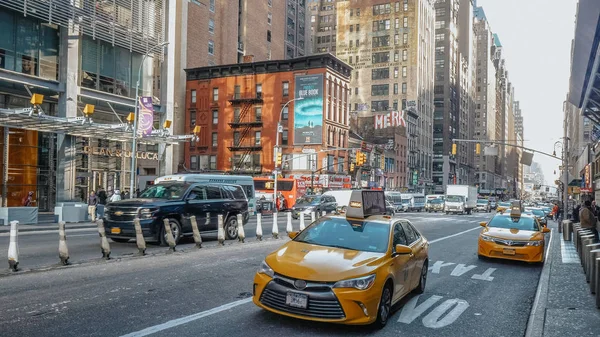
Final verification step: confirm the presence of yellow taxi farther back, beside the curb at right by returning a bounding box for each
[477,202,550,263]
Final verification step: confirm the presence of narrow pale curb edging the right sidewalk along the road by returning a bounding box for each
[525,222,555,337]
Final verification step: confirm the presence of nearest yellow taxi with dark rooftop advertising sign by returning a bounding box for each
[253,190,429,328]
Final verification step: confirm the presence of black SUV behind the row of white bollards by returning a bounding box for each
[104,182,250,245]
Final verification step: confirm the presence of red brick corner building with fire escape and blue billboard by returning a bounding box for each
[184,54,352,181]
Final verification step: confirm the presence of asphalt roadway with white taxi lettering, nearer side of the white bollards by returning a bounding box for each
[0,214,542,337]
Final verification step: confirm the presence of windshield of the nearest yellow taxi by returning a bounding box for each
[294,218,390,253]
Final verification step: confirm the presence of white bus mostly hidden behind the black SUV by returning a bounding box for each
[154,173,256,214]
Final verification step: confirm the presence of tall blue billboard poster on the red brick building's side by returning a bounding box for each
[294,74,323,145]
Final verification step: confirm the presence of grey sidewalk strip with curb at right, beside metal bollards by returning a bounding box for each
[525,221,600,337]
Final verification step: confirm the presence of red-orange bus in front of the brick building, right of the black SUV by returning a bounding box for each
[254,177,306,209]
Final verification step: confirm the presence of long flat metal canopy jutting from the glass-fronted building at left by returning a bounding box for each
[0,108,194,144]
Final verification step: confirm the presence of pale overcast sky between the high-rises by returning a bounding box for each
[477,0,577,184]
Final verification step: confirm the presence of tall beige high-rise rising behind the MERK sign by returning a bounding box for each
[336,0,434,193]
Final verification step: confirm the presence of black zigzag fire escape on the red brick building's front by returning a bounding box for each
[228,92,263,174]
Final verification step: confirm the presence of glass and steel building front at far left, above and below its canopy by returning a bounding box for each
[0,0,182,211]
